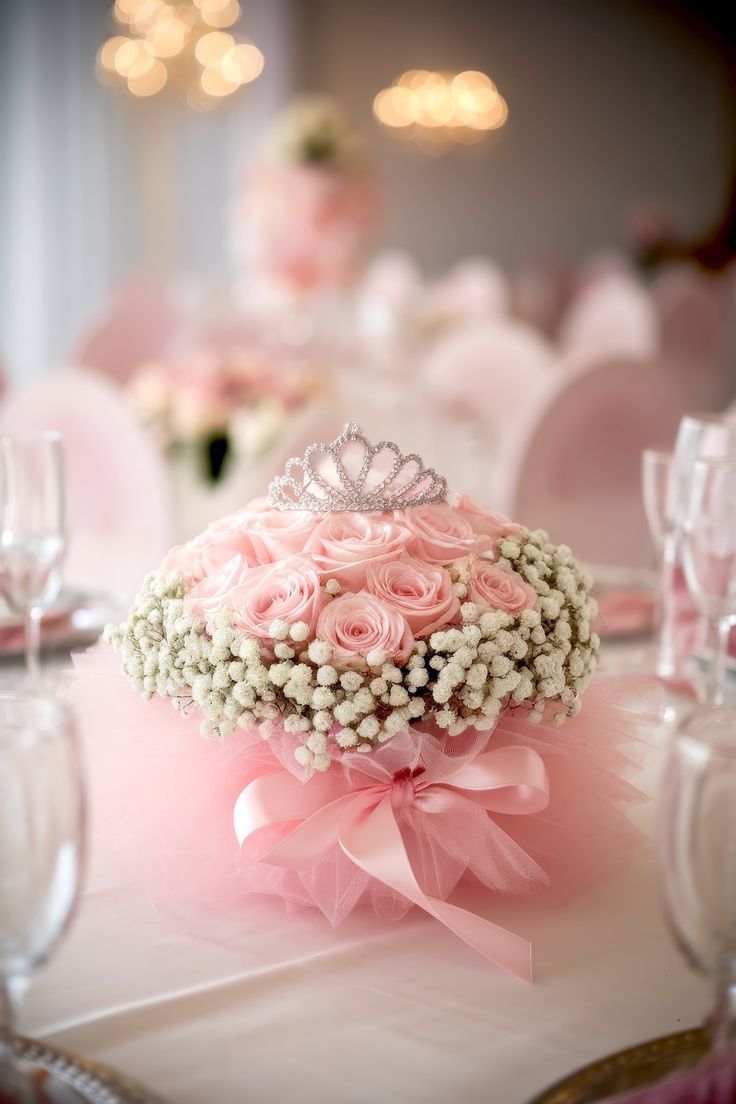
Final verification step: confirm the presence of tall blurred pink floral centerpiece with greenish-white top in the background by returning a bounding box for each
[231,96,377,301]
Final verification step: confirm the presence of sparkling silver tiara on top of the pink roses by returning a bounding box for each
[268,422,447,513]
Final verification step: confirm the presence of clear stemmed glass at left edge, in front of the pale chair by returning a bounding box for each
[0,433,66,680]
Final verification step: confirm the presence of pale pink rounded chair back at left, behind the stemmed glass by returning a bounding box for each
[0,369,171,595]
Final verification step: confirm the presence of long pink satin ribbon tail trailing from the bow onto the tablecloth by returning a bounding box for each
[338,796,532,981]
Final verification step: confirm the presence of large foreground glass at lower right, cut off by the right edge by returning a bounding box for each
[658,709,736,1100]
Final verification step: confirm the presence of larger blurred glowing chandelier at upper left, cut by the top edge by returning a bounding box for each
[96,0,264,110]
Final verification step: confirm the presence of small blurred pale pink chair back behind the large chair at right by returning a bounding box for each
[559,272,660,369]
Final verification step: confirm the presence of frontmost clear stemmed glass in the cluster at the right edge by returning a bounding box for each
[683,458,736,705]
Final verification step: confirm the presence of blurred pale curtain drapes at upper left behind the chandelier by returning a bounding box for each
[0,0,298,382]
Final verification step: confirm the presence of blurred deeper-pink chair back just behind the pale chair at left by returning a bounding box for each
[71,282,182,383]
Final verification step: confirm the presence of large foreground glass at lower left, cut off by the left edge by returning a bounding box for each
[0,692,85,1101]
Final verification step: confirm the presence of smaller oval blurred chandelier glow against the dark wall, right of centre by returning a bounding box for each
[373,70,509,146]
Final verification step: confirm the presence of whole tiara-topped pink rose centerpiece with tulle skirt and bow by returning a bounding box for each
[71,424,648,978]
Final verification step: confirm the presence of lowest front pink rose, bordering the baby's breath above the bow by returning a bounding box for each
[317,592,414,670]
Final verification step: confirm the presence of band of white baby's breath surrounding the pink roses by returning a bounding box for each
[105,531,599,771]
